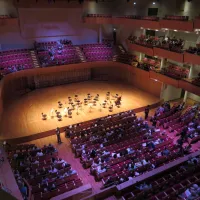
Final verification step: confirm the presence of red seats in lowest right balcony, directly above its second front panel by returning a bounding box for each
[161,64,189,79]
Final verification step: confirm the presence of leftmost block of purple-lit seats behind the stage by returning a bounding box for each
[0,49,33,75]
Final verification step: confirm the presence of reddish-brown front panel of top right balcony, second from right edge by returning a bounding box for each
[160,19,194,32]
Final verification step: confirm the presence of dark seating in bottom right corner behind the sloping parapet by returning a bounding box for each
[122,157,200,200]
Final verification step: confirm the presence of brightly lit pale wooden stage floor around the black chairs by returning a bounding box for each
[0,81,159,140]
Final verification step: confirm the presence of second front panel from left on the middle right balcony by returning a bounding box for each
[153,47,184,63]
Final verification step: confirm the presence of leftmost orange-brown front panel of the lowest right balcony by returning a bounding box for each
[149,71,178,87]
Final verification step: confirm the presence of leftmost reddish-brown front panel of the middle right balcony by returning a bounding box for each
[127,40,154,56]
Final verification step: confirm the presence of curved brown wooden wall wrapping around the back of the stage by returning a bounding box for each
[0,61,161,122]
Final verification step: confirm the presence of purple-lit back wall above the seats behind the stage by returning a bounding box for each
[0,8,102,50]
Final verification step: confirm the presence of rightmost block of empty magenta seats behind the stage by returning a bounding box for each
[80,44,113,62]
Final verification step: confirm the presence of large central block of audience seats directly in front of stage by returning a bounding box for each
[68,108,180,187]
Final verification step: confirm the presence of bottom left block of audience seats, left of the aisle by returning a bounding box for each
[7,144,82,200]
